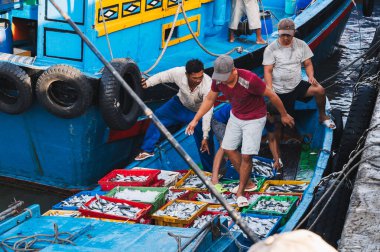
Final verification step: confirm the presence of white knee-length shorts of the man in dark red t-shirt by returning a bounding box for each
[222,113,267,155]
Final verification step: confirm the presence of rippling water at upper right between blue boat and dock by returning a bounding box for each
[314,1,380,119]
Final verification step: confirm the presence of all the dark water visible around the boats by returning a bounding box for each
[0,1,380,215]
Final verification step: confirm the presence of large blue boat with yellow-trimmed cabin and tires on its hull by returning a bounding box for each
[0,0,353,189]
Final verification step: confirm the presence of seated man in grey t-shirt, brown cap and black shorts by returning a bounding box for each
[263,18,335,129]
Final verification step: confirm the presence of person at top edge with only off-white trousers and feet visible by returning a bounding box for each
[229,0,266,44]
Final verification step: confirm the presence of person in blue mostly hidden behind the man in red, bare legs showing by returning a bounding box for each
[211,103,283,192]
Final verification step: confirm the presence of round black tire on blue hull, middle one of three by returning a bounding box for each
[36,65,94,118]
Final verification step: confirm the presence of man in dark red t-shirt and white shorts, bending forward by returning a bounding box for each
[186,55,294,207]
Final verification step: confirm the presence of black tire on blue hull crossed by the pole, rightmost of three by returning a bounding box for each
[99,59,142,130]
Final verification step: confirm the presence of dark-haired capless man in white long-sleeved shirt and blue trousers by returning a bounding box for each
[135,59,214,171]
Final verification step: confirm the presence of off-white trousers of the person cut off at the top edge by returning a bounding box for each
[229,0,261,30]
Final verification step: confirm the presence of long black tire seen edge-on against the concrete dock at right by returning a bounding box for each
[333,81,378,172]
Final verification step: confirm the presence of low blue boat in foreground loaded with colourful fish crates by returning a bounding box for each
[0,94,333,251]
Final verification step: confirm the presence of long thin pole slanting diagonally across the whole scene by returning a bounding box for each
[49,0,259,242]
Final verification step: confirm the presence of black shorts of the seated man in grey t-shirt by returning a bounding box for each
[277,80,313,117]
